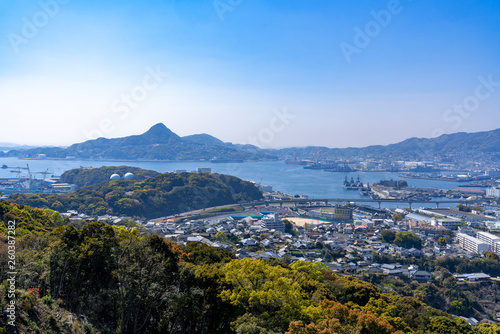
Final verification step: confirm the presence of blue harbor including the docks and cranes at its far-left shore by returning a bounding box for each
[0,158,494,207]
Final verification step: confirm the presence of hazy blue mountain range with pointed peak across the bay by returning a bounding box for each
[0,123,500,161]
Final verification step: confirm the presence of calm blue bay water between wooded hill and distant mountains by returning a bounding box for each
[0,158,468,207]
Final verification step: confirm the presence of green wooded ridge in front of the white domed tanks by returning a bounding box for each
[10,173,262,219]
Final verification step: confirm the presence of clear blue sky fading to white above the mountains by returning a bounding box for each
[0,0,500,147]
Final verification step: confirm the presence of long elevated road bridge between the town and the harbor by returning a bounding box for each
[240,198,491,209]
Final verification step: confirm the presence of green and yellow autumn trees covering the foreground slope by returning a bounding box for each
[0,214,496,334]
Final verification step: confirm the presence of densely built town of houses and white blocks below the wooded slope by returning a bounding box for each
[63,187,500,280]
